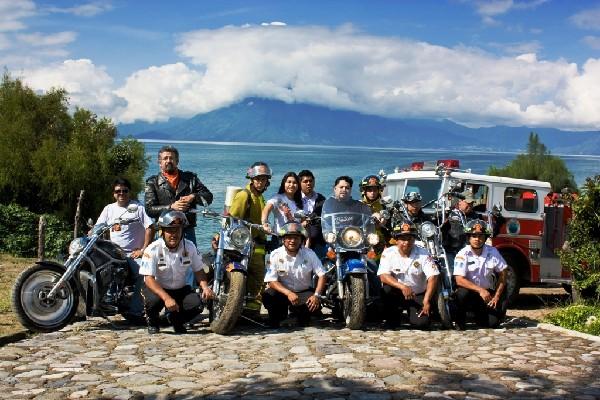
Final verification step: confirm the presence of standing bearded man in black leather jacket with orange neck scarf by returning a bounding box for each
[144,146,213,244]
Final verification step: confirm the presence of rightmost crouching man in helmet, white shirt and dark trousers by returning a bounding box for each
[454,219,507,329]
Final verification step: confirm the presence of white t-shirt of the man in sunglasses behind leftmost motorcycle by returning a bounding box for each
[96,201,152,254]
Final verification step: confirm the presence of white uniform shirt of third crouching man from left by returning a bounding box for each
[377,246,440,294]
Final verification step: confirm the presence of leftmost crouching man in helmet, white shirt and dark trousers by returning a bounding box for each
[140,210,214,334]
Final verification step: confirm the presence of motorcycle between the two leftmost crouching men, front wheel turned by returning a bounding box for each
[199,207,264,335]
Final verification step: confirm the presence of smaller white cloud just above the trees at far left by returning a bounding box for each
[23,59,122,115]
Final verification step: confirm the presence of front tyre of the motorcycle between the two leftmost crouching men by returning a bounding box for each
[210,271,246,335]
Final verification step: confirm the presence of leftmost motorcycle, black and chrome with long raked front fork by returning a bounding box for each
[12,204,144,332]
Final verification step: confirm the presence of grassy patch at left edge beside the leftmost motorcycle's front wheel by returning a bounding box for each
[0,254,35,337]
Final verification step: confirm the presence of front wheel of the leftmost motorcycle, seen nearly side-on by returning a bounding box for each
[12,264,79,332]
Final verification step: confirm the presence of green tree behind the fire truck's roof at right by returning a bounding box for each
[488,132,577,192]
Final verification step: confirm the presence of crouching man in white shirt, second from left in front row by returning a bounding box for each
[263,222,326,327]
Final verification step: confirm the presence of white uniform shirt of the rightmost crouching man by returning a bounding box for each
[454,244,507,289]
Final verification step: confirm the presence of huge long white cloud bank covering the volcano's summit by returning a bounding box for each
[109,26,600,129]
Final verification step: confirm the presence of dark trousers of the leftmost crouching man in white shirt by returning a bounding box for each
[142,285,202,327]
